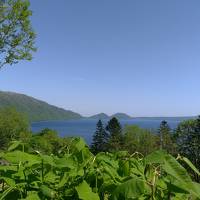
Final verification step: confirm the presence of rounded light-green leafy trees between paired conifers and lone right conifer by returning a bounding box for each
[123,125,159,155]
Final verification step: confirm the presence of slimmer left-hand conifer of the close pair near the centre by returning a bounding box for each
[91,120,108,154]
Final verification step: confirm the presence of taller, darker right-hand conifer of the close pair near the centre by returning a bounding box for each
[106,117,123,152]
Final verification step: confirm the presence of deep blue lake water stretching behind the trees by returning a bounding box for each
[32,119,184,144]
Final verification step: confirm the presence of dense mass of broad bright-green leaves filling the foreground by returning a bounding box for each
[0,138,200,200]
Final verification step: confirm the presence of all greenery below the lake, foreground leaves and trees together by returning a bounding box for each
[0,108,200,200]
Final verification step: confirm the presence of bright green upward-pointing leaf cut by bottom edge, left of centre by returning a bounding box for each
[76,181,100,200]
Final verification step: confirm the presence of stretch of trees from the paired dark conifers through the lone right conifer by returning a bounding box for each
[91,117,173,156]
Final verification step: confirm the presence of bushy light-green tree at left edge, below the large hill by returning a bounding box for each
[0,108,29,149]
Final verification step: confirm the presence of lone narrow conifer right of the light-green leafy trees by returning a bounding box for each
[158,120,174,153]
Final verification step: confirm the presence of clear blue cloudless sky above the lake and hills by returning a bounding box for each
[0,0,200,116]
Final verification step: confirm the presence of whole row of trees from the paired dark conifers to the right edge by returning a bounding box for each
[91,117,200,182]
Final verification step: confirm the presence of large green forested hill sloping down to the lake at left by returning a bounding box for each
[0,91,82,121]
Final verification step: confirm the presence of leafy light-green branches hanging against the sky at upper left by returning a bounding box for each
[0,0,36,69]
